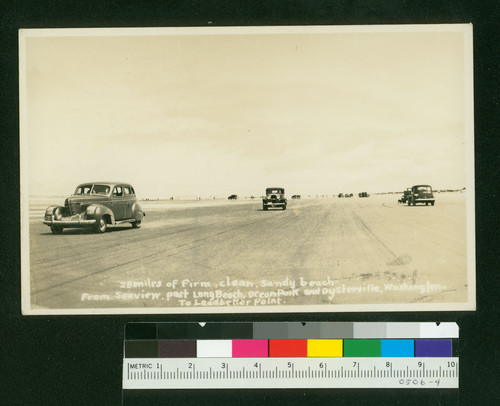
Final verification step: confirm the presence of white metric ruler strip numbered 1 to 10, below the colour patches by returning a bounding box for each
[123,358,458,389]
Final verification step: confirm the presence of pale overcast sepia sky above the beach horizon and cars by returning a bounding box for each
[21,26,472,197]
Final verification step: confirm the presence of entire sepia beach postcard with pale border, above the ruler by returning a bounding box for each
[19,24,475,315]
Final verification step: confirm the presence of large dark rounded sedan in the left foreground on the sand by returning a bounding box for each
[43,182,146,234]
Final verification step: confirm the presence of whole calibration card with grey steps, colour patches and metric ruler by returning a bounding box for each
[123,323,459,390]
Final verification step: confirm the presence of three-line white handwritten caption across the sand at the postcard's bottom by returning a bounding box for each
[80,277,446,307]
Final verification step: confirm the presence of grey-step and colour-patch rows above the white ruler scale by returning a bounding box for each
[124,322,458,358]
